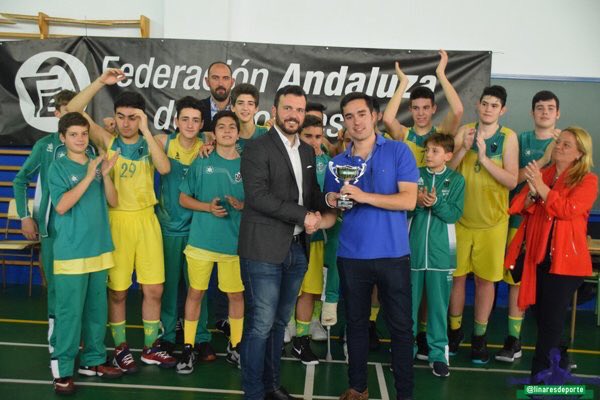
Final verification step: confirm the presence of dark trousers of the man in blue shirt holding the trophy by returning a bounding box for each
[338,256,413,398]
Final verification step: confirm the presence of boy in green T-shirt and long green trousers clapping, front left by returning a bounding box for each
[48,112,122,394]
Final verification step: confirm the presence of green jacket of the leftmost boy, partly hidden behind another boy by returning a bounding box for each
[13,133,66,237]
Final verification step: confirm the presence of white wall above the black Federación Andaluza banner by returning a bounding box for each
[0,0,600,79]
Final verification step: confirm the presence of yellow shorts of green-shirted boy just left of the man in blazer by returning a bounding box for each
[183,244,244,293]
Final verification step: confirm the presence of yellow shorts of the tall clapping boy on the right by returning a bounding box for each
[454,220,508,282]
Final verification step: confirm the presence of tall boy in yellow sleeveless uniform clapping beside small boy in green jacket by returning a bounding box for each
[448,86,519,364]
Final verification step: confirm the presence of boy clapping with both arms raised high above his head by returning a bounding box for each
[383,50,463,164]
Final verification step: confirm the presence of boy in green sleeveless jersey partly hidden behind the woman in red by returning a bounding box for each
[495,90,560,362]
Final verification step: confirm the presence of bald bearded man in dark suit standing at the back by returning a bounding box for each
[200,61,235,132]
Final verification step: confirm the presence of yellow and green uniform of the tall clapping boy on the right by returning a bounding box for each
[454,123,515,282]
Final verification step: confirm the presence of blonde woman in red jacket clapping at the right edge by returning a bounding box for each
[505,127,598,377]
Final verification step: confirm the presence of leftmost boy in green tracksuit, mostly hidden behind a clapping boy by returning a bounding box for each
[13,90,76,354]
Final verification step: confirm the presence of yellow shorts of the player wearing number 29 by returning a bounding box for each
[108,207,165,291]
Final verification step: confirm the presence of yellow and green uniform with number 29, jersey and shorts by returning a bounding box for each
[108,135,165,291]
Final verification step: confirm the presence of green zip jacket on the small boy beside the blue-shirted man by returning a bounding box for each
[409,167,465,271]
